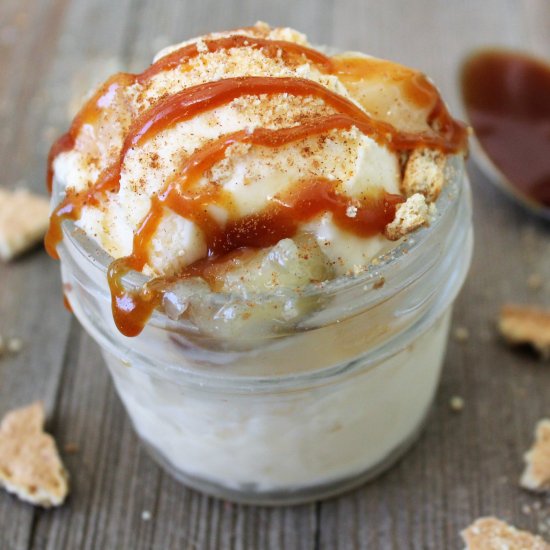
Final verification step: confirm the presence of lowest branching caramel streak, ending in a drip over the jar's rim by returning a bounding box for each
[108,115,403,336]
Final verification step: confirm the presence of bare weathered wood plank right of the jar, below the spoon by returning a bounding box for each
[320,169,550,550]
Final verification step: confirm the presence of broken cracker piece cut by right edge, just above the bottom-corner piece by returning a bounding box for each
[520,418,550,491]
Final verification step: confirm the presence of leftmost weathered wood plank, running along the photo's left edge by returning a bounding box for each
[0,0,70,549]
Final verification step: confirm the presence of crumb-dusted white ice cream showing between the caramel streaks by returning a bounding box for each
[54,25,401,275]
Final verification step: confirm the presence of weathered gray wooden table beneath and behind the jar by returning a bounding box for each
[0,0,550,550]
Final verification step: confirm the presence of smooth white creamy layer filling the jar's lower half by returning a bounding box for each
[104,310,450,492]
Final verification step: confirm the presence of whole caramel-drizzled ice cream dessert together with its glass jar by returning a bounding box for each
[46,23,472,504]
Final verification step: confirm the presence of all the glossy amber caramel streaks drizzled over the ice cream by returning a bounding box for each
[45,35,466,336]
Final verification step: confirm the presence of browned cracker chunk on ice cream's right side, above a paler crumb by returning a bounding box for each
[401,148,447,202]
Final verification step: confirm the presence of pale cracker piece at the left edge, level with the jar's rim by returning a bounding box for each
[0,189,50,261]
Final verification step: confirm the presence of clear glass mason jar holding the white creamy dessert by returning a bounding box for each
[58,157,472,505]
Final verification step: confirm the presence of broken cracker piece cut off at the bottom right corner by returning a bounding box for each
[461,517,550,550]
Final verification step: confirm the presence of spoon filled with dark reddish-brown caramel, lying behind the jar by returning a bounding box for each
[461,49,550,219]
